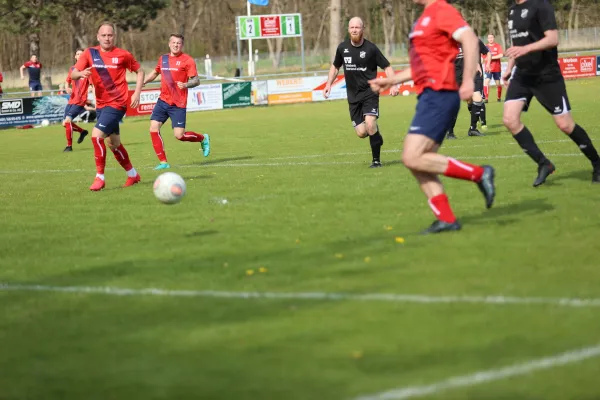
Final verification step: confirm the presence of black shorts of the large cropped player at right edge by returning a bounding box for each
[504,76,571,115]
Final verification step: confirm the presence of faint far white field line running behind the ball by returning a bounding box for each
[0,153,582,175]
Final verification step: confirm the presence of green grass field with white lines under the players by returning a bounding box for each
[0,79,600,400]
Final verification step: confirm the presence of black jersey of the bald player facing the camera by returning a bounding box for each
[333,39,390,103]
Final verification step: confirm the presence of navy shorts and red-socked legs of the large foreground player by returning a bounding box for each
[402,89,495,233]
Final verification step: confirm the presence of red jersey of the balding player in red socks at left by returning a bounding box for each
[74,46,140,110]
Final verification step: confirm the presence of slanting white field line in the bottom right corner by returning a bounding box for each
[355,345,600,400]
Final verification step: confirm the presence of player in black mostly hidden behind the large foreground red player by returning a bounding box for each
[446,39,492,139]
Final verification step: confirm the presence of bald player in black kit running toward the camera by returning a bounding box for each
[323,17,398,168]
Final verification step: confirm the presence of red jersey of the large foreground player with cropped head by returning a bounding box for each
[408,0,469,94]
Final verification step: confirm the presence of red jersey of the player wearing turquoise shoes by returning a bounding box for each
[154,53,198,108]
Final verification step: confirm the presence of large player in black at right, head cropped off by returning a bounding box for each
[503,0,600,187]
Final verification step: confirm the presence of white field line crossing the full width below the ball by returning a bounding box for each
[0,282,600,308]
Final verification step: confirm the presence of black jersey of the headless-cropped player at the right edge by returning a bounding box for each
[508,0,560,76]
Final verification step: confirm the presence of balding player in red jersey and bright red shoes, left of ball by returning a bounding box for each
[71,22,144,191]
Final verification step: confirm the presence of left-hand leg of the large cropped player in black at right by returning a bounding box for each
[502,78,555,187]
